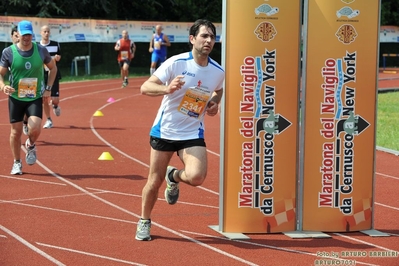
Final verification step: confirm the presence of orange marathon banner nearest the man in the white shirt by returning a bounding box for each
[220,0,301,233]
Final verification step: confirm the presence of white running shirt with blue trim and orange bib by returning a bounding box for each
[150,52,225,140]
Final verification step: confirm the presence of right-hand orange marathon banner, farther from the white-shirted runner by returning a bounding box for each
[302,0,380,232]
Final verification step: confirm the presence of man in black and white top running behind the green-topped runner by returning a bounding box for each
[40,25,61,128]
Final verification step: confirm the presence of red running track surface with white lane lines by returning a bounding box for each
[0,75,399,266]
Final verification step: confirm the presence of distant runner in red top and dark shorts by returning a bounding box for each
[114,30,136,88]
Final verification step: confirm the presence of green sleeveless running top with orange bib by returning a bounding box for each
[10,42,44,102]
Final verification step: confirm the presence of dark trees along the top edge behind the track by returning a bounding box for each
[0,0,399,26]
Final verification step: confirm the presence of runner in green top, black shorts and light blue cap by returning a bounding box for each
[0,20,57,175]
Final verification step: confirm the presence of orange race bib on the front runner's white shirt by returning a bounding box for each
[178,87,211,118]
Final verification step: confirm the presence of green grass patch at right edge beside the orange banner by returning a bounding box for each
[377,92,399,151]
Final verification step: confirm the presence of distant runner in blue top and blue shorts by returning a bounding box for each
[148,25,170,75]
